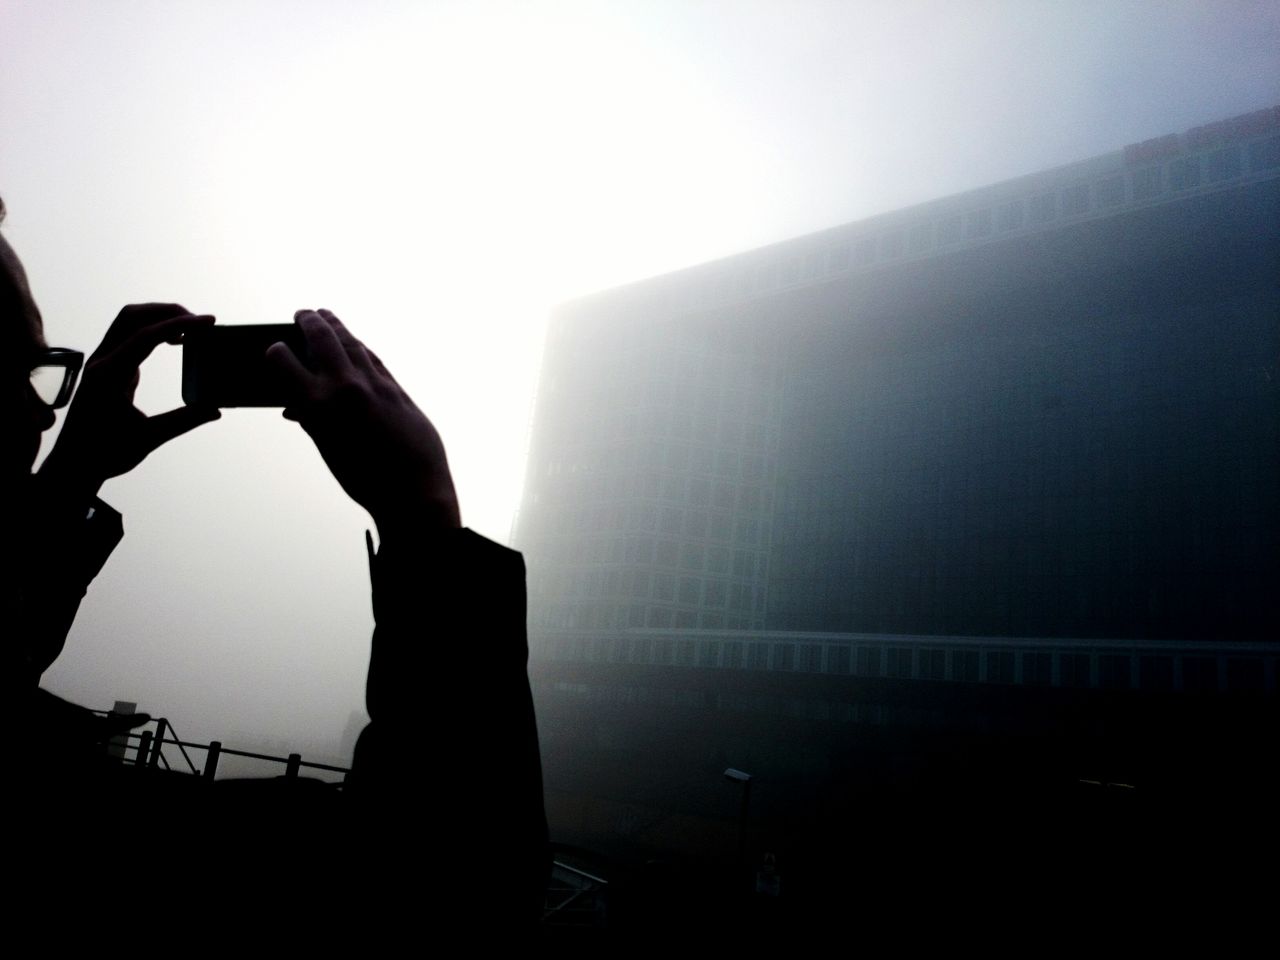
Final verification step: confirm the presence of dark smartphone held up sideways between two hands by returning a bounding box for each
[182,324,306,407]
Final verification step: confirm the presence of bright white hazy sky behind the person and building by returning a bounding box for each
[0,0,1280,741]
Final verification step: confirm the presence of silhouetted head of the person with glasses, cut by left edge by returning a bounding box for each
[0,200,55,483]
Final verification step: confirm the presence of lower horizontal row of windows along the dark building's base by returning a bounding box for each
[545,636,1276,692]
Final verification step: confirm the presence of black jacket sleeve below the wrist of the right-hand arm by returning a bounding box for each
[348,530,550,920]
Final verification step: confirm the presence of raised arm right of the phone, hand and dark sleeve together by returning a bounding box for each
[268,311,549,923]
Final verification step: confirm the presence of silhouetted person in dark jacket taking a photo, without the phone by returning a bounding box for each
[0,195,549,946]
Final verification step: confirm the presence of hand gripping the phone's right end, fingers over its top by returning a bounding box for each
[266,310,461,543]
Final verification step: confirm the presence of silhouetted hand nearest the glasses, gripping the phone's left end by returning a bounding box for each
[40,303,221,497]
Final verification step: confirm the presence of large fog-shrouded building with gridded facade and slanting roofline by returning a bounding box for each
[515,108,1280,691]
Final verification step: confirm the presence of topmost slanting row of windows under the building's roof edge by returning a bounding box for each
[665,137,1280,316]
